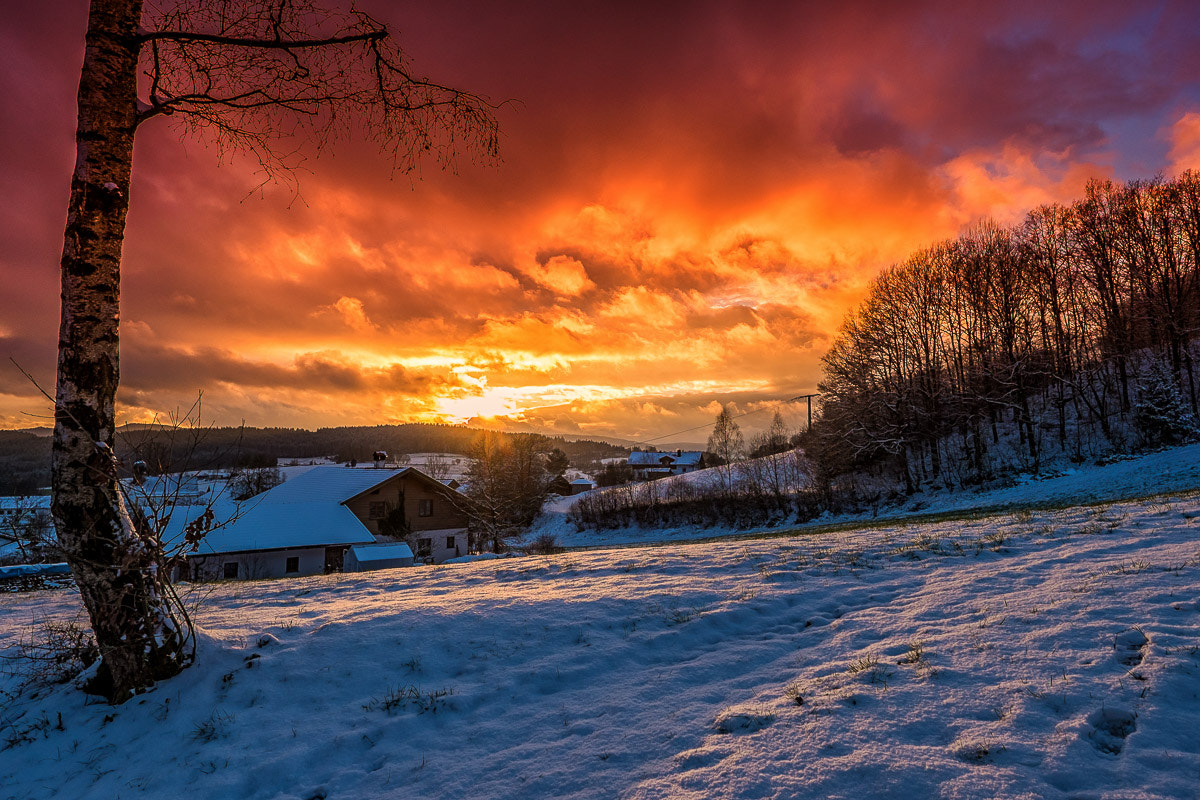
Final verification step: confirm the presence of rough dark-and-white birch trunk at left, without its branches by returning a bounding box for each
[52,0,187,702]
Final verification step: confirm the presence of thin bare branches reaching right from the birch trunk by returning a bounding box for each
[138,0,499,180]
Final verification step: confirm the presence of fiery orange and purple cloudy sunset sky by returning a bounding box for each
[0,0,1200,441]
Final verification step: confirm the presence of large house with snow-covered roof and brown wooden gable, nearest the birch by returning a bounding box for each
[174,467,469,579]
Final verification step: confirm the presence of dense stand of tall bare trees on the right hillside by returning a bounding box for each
[816,172,1200,492]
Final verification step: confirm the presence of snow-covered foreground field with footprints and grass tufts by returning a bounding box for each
[0,493,1200,800]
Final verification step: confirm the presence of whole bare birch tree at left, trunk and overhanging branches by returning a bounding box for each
[52,0,497,702]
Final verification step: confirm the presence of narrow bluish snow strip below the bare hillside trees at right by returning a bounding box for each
[537,444,1200,547]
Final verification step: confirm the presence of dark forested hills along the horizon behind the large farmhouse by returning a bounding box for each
[0,423,628,495]
